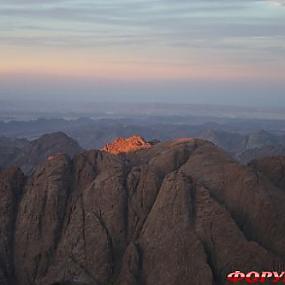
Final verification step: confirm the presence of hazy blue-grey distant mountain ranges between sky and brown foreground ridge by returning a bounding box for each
[0,117,285,169]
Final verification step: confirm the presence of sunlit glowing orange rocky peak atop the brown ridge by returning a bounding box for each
[103,135,152,154]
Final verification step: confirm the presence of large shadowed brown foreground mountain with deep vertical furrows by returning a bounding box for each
[0,139,285,285]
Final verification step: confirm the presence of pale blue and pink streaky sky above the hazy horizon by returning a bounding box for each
[0,0,285,107]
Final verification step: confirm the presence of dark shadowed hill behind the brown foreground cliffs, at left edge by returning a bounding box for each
[0,132,82,174]
